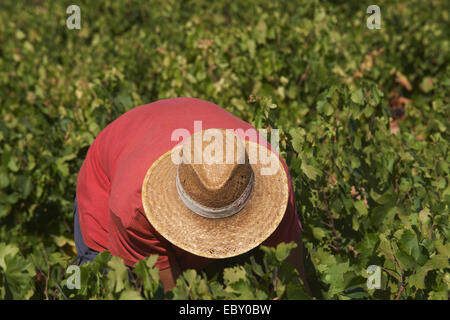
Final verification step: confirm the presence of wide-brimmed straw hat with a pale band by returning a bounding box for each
[142,129,289,259]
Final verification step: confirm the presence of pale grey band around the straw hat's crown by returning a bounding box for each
[176,170,254,218]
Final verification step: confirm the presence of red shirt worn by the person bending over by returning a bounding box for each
[76,98,301,269]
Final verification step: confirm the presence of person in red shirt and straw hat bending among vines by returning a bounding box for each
[74,98,307,290]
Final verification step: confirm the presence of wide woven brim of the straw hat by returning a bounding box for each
[142,140,289,259]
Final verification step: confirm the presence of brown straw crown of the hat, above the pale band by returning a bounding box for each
[178,129,253,208]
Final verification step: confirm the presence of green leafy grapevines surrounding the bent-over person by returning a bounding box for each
[0,0,450,300]
